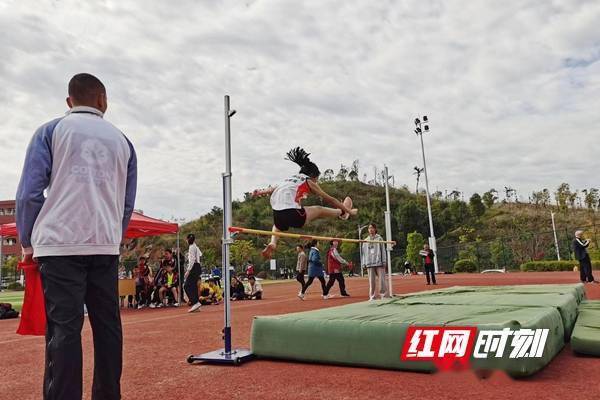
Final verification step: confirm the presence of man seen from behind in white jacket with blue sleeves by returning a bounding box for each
[16,74,137,400]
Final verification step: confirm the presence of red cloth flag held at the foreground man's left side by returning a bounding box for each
[17,262,46,336]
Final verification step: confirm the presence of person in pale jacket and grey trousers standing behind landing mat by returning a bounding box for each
[361,224,387,301]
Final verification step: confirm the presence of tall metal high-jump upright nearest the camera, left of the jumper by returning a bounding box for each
[222,96,232,354]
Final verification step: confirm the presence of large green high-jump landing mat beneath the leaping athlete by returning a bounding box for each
[251,285,583,377]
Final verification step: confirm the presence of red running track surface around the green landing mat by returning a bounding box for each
[0,272,600,400]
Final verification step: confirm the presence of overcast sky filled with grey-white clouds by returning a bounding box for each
[0,0,600,219]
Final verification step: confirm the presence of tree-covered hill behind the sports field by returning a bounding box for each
[125,179,600,270]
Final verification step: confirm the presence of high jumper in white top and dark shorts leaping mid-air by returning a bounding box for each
[253,147,358,258]
